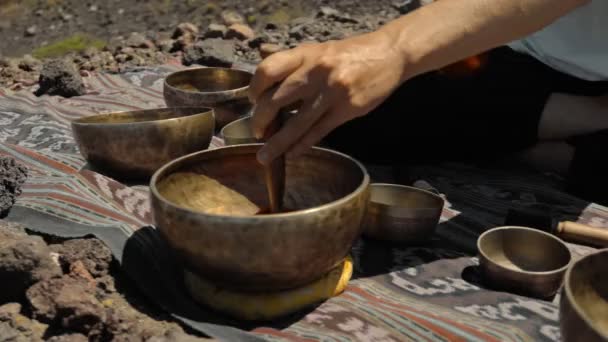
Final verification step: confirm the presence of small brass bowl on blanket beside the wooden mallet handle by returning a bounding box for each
[477,226,572,298]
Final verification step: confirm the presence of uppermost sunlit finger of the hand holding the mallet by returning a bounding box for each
[249,49,304,103]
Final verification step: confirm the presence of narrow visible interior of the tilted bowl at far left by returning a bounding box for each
[74,107,212,125]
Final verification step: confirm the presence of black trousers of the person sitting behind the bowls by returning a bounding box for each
[324,47,608,203]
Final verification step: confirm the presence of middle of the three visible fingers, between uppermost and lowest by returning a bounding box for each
[252,71,314,139]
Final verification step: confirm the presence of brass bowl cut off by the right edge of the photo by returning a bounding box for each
[559,249,608,342]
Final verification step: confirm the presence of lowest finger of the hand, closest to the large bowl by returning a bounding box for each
[257,95,331,164]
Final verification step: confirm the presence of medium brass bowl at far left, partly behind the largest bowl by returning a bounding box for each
[71,108,215,179]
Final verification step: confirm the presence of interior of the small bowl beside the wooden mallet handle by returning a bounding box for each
[479,227,571,272]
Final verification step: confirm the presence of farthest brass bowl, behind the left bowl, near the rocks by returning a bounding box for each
[163,67,253,129]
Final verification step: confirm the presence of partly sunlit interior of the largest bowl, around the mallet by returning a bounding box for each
[155,144,368,216]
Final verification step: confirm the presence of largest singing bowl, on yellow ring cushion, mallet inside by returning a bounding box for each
[150,144,369,291]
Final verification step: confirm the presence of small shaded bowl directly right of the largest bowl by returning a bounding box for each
[364,183,444,244]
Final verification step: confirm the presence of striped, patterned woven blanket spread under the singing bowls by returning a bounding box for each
[0,64,608,341]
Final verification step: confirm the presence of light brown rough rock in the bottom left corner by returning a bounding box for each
[0,303,48,341]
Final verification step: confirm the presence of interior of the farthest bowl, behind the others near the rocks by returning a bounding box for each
[165,68,253,92]
